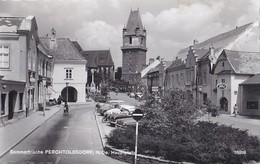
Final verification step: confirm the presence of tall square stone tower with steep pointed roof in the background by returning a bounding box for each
[121,10,147,85]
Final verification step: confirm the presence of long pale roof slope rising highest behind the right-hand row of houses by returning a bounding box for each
[178,23,253,57]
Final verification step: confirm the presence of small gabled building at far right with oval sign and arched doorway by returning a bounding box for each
[214,50,260,115]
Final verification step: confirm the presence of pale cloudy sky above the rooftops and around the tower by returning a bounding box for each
[0,0,260,67]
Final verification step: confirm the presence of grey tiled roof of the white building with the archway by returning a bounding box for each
[40,37,86,62]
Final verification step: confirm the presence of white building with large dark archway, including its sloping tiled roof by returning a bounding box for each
[40,29,87,102]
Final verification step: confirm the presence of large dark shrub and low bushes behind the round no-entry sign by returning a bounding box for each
[107,89,260,164]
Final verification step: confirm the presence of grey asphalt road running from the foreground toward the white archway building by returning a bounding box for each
[0,105,126,164]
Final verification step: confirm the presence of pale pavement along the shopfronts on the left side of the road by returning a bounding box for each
[0,106,62,158]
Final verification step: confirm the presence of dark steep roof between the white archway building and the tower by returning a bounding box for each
[82,50,114,68]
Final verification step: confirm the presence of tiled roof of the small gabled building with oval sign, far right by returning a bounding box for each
[222,50,260,74]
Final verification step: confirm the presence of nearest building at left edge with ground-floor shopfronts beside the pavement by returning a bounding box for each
[0,16,52,120]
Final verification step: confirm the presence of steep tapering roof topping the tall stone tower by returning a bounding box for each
[125,10,144,35]
